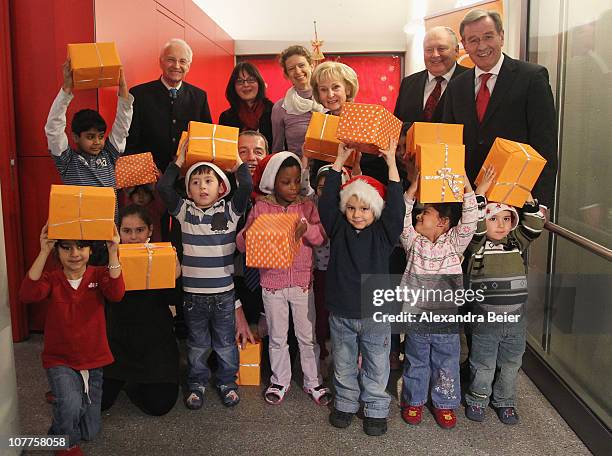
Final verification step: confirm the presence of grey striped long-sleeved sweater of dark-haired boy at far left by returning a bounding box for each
[45,89,134,187]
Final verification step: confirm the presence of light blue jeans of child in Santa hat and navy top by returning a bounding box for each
[329,314,391,418]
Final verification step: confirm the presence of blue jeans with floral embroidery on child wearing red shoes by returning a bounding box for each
[402,333,461,409]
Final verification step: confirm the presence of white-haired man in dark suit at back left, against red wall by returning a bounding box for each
[126,38,212,171]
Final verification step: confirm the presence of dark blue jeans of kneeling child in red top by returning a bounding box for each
[47,366,102,446]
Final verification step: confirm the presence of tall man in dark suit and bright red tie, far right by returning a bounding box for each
[442,9,557,207]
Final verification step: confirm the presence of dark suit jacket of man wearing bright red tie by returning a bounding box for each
[442,55,557,208]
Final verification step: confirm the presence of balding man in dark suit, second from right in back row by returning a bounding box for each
[394,27,467,123]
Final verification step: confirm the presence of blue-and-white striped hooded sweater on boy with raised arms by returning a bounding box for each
[157,163,253,294]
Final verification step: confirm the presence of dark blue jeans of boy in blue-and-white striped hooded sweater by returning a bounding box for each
[183,290,238,391]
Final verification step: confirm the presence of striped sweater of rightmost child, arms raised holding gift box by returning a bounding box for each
[466,197,546,313]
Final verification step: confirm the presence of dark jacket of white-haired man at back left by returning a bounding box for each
[126,79,212,171]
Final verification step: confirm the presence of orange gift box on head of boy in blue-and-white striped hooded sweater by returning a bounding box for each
[179,121,240,171]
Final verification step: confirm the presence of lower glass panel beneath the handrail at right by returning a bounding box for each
[544,239,612,427]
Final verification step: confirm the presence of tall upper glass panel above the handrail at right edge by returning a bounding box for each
[546,0,612,247]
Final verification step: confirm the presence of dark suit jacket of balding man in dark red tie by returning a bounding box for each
[394,64,467,124]
